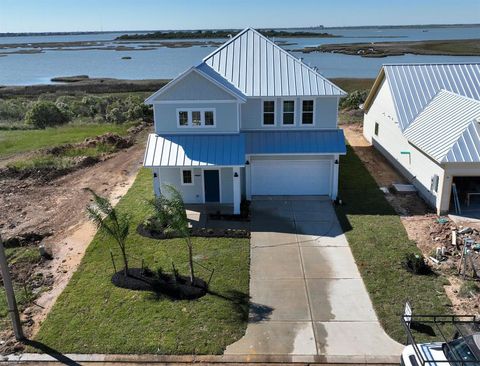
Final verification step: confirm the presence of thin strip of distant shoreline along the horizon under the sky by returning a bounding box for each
[0,23,480,37]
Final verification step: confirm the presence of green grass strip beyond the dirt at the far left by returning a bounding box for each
[0,123,132,157]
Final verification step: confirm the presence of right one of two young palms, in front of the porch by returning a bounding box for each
[152,184,195,285]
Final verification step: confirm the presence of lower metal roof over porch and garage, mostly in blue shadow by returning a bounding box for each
[143,130,346,167]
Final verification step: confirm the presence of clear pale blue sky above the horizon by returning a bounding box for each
[0,0,480,33]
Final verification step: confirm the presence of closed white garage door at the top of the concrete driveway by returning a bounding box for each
[251,159,332,196]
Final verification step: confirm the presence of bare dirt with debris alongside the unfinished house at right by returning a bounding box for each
[341,123,480,314]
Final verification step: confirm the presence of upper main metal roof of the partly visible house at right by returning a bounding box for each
[383,63,480,131]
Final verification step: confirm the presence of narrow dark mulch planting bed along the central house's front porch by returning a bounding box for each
[137,224,250,240]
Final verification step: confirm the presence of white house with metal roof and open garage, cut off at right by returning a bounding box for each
[363,64,480,214]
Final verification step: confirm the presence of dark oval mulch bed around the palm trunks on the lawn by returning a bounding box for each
[112,268,208,300]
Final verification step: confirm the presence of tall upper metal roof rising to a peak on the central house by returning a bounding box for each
[203,28,346,97]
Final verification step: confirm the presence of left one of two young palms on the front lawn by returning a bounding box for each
[85,188,130,276]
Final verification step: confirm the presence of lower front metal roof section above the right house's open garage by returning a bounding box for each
[404,90,480,163]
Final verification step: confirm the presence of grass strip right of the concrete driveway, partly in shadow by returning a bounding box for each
[337,147,451,343]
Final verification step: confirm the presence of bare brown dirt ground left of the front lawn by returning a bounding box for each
[0,132,146,353]
